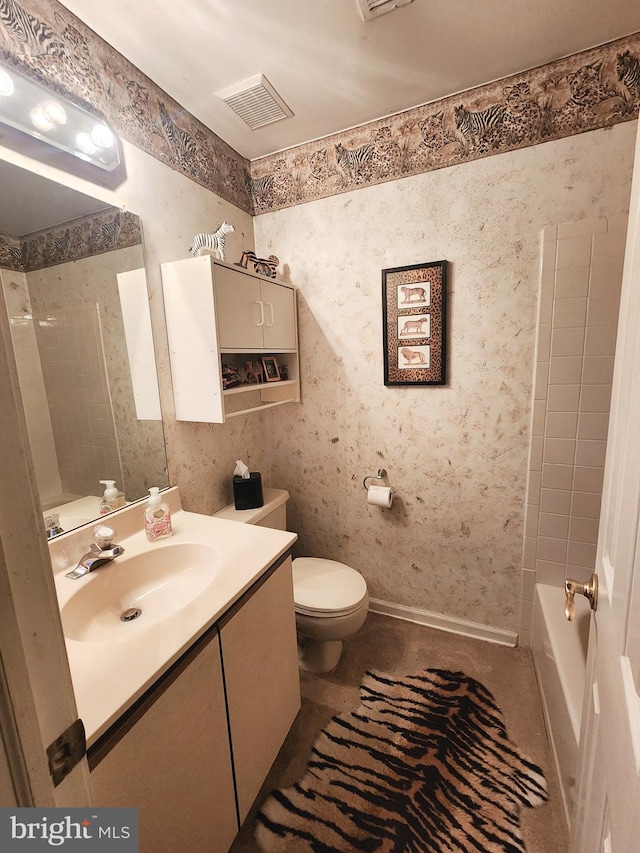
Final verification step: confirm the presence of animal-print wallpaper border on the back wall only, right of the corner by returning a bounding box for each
[250,33,640,215]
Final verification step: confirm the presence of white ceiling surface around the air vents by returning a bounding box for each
[57,0,640,159]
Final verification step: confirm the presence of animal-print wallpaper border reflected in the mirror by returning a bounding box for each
[0,207,142,272]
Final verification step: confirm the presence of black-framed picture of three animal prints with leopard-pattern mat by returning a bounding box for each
[382,261,447,385]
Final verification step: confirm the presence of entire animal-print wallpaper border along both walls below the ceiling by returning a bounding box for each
[0,0,640,215]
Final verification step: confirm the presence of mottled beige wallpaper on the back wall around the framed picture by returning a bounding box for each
[255,122,636,630]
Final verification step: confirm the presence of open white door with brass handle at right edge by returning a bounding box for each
[571,123,640,853]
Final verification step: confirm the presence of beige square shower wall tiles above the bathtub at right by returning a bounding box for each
[520,216,627,645]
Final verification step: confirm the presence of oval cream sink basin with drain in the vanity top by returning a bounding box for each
[60,543,218,642]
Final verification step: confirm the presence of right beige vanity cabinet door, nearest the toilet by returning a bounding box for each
[220,557,300,823]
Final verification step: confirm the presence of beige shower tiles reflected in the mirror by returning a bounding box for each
[0,269,122,502]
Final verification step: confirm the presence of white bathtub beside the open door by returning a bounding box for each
[531,584,591,826]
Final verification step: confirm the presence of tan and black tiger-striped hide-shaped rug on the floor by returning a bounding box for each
[255,669,547,853]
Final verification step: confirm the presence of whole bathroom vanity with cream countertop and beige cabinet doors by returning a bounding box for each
[52,490,300,853]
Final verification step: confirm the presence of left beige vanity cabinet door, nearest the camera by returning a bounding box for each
[89,633,238,853]
